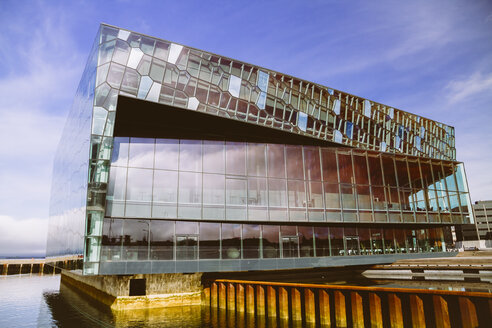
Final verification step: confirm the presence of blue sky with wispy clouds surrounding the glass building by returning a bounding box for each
[0,0,492,256]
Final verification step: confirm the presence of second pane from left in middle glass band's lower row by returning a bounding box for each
[125,168,154,218]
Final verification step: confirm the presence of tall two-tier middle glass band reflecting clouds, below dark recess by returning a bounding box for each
[106,137,470,223]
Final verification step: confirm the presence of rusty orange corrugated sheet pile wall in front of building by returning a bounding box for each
[202,279,492,327]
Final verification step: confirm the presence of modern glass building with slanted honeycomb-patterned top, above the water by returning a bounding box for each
[47,25,473,274]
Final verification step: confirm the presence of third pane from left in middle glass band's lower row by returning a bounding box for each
[152,170,178,218]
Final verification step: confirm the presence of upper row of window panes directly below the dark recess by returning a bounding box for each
[111,137,467,192]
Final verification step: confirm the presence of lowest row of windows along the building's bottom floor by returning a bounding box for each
[101,218,449,261]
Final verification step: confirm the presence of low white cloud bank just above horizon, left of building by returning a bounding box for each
[0,215,48,256]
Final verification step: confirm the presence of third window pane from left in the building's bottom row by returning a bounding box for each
[150,220,174,260]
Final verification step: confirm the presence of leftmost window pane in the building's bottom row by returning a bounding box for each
[101,218,123,261]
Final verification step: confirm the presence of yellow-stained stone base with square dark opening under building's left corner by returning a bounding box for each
[61,270,202,311]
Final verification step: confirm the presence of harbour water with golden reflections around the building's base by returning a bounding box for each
[0,273,492,328]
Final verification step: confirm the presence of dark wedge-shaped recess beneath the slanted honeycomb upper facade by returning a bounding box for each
[114,95,343,147]
